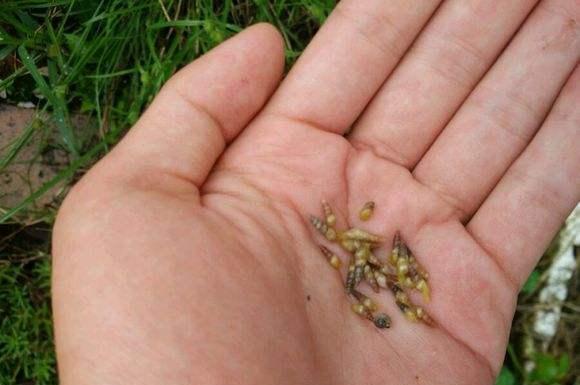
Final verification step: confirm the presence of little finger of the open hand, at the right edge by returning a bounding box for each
[467,67,580,286]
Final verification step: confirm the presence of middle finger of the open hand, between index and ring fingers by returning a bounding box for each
[350,0,536,168]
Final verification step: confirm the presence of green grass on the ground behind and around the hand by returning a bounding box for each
[0,0,578,385]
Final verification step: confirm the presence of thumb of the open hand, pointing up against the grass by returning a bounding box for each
[107,24,284,187]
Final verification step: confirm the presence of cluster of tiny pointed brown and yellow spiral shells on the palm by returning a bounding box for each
[310,201,433,328]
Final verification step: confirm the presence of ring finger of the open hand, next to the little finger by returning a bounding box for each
[414,0,580,218]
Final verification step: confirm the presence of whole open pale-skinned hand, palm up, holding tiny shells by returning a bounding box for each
[53,0,580,385]
